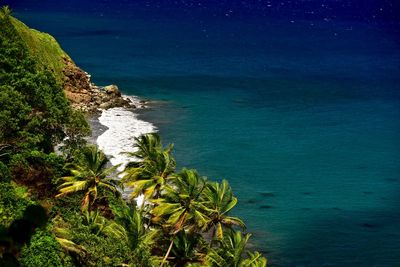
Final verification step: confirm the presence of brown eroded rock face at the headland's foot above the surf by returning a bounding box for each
[64,58,135,113]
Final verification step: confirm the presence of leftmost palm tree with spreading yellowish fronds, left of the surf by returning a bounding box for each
[56,146,119,210]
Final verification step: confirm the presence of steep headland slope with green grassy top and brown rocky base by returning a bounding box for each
[10,17,134,113]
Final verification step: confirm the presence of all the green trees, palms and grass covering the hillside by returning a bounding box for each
[0,7,267,267]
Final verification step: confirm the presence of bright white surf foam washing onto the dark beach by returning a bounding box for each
[97,107,157,205]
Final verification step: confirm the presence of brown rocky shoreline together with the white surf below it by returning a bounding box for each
[63,52,157,205]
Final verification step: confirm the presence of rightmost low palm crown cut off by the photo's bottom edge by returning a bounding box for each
[206,230,267,267]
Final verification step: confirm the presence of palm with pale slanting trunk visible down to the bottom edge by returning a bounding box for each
[151,169,209,265]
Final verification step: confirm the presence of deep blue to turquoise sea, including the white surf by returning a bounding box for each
[8,1,400,266]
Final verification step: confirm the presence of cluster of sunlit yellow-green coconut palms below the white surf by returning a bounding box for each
[54,133,267,266]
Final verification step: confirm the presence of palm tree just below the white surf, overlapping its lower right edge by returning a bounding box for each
[122,133,176,203]
